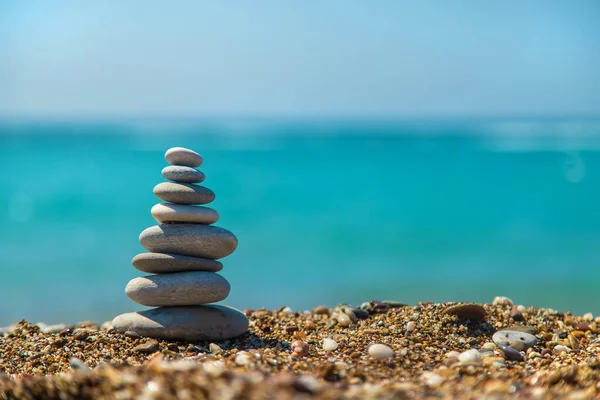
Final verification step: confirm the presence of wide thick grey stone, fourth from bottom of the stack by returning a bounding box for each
[140,224,238,260]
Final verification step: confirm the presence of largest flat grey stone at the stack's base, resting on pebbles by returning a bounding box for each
[113,306,248,342]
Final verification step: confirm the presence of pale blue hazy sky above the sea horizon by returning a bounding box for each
[0,0,600,117]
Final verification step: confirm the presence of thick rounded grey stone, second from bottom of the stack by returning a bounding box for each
[125,271,231,306]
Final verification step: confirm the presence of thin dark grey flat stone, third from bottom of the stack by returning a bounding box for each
[131,253,223,274]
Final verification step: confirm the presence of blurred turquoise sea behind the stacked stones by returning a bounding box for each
[0,119,600,326]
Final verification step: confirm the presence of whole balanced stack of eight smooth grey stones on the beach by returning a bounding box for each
[113,147,248,341]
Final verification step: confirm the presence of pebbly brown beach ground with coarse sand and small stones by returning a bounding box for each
[0,298,600,400]
